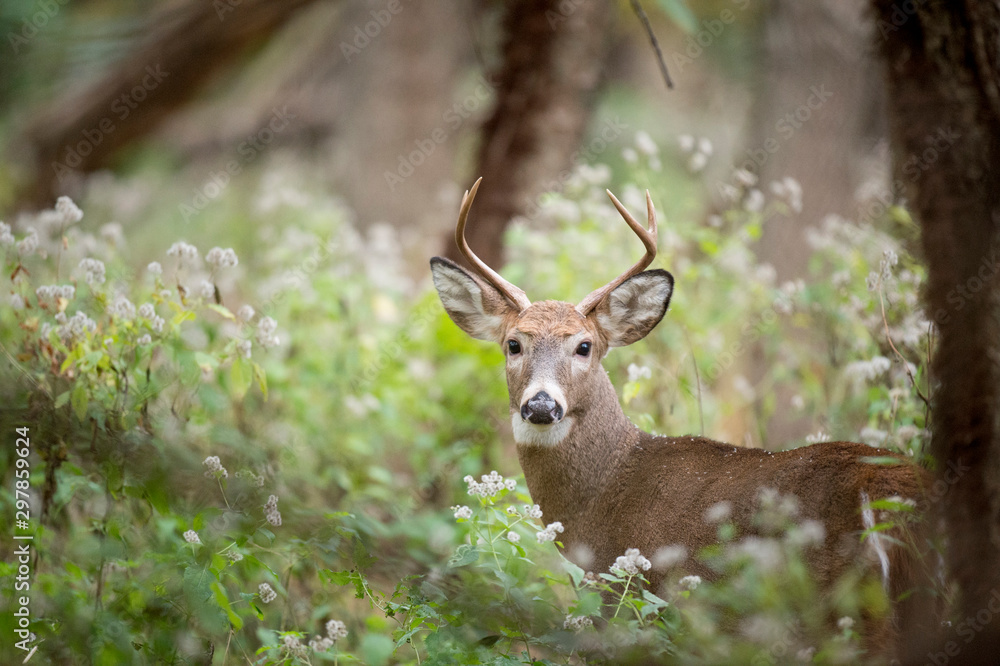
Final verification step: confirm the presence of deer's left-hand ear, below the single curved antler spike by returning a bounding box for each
[431,257,518,344]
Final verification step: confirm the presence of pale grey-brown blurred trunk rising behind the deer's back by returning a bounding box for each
[736,0,884,448]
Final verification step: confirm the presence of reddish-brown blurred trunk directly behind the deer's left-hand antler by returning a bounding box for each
[444,0,615,267]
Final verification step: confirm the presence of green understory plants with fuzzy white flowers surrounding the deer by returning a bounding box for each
[0,135,934,665]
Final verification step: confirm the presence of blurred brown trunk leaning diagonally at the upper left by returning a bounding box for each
[19,0,315,205]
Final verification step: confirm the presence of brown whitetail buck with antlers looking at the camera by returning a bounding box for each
[431,179,925,644]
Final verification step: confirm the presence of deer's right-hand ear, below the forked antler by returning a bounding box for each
[590,269,674,347]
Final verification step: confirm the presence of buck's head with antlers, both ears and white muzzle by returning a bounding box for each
[431,179,674,446]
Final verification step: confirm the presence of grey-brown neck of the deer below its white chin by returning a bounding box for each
[517,372,641,532]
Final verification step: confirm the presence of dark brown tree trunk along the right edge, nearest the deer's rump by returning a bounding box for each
[873,0,1000,664]
